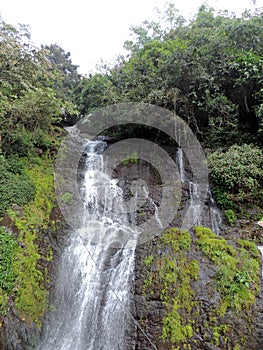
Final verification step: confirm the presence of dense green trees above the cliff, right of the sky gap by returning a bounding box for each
[76,3,263,148]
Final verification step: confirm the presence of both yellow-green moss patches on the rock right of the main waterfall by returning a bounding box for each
[143,227,260,349]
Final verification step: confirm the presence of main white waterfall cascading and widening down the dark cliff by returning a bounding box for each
[37,141,140,350]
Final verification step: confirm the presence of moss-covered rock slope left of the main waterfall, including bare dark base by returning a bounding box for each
[0,156,62,350]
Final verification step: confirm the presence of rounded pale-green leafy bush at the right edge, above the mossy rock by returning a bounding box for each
[208,144,263,193]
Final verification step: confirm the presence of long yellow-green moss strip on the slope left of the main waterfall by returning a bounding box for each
[2,158,55,327]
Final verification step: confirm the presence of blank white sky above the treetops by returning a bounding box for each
[0,0,263,74]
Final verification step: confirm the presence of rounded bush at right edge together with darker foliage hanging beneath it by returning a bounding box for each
[207,144,263,216]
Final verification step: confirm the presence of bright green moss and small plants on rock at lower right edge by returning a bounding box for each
[195,227,260,315]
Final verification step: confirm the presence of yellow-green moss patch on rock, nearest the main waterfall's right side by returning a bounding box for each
[145,228,199,349]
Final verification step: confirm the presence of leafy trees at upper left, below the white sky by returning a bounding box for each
[0,18,78,156]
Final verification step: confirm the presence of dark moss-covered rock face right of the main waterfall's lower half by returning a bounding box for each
[136,227,263,350]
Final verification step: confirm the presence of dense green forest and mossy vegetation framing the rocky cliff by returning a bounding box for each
[0,4,263,340]
